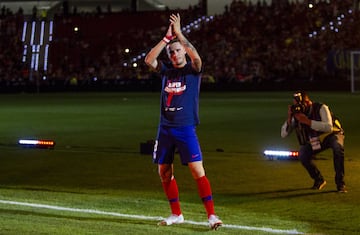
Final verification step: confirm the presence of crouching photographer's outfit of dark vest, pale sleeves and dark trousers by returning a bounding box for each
[281,103,345,190]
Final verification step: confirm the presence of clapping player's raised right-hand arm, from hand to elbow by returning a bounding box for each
[170,14,202,72]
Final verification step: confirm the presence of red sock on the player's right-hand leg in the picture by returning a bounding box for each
[196,176,215,217]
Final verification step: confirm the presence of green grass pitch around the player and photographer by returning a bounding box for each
[0,92,360,234]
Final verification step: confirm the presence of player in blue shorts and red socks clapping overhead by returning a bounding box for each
[145,14,222,230]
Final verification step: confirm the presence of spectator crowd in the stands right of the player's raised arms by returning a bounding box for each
[193,0,360,82]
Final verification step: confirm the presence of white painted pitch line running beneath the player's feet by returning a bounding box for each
[0,200,304,234]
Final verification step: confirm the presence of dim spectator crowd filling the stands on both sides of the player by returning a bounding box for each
[0,0,360,92]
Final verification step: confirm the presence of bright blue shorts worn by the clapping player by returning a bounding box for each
[153,126,202,165]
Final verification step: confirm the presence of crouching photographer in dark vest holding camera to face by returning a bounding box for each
[281,91,347,193]
